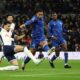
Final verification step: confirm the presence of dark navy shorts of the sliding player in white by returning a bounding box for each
[3,45,16,61]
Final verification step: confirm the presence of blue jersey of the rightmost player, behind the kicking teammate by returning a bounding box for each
[48,20,63,38]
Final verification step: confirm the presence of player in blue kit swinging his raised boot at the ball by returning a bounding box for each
[20,9,54,70]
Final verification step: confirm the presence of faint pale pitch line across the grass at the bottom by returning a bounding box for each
[9,73,80,78]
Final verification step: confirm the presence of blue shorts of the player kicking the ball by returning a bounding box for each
[31,37,46,49]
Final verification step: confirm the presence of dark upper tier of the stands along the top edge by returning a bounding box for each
[0,0,80,15]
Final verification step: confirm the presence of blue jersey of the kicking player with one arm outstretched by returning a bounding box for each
[25,16,44,39]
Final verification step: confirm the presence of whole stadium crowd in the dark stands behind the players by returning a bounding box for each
[0,0,80,51]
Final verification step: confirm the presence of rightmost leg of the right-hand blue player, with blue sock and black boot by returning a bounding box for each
[61,41,71,68]
